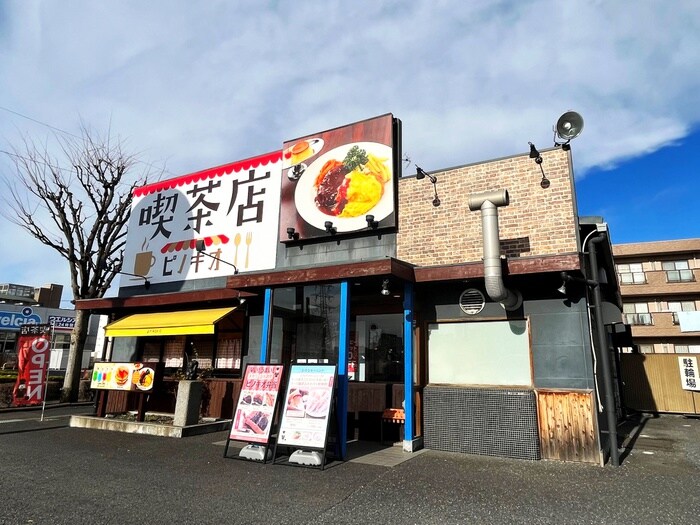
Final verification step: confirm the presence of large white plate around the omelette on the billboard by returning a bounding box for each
[294,142,394,232]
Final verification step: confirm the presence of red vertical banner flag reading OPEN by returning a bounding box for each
[12,324,51,406]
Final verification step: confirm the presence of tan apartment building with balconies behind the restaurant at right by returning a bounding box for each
[613,239,700,354]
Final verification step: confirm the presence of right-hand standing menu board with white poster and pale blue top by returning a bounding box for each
[277,365,336,449]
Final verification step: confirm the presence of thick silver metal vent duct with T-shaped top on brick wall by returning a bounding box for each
[467,190,523,311]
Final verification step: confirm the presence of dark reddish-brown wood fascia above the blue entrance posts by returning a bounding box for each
[226,258,415,289]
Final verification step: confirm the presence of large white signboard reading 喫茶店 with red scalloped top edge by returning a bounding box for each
[121,152,282,286]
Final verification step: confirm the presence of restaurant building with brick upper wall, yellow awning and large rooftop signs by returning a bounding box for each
[76,115,621,463]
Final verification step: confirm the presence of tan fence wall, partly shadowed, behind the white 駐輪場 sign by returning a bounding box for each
[620,354,700,414]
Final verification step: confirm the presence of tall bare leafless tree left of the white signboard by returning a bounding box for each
[2,126,160,402]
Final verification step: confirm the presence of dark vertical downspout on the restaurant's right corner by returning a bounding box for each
[584,233,620,467]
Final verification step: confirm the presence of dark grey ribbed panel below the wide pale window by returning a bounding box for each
[424,385,540,460]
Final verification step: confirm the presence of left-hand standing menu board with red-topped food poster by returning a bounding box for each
[229,364,284,445]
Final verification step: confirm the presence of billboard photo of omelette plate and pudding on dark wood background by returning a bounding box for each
[279,114,400,242]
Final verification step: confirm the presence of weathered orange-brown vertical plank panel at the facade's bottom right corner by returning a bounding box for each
[537,390,600,463]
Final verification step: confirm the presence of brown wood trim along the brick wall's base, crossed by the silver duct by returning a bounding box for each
[413,253,583,283]
